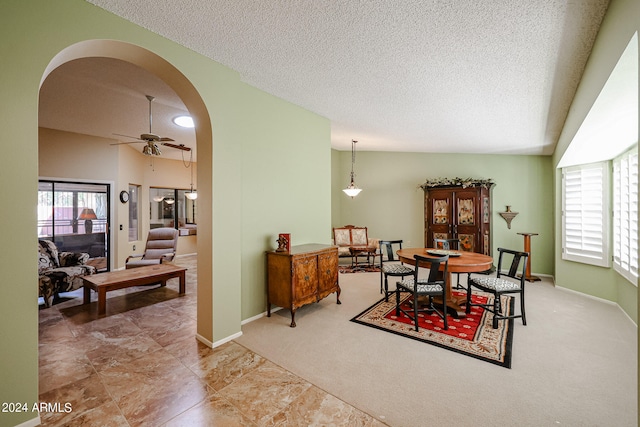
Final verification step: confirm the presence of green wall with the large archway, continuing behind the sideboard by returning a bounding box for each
[0,0,331,426]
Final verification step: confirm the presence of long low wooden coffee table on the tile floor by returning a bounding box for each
[82,264,187,314]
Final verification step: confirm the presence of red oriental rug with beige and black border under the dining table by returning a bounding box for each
[351,291,514,368]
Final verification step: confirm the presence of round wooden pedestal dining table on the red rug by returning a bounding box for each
[396,248,493,318]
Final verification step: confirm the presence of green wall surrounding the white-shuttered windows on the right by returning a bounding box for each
[553,0,640,324]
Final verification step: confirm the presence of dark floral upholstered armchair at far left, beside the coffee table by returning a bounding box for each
[38,239,96,307]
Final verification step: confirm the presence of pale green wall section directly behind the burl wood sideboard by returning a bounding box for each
[238,88,331,320]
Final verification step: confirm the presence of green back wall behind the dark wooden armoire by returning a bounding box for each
[329,152,554,275]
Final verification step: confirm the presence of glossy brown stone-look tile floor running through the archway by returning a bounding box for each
[39,257,384,427]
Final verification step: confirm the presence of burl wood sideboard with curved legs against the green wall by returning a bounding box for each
[267,243,341,328]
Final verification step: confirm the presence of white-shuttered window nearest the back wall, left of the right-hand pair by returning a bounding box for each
[562,162,609,267]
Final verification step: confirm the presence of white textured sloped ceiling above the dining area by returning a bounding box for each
[41,0,609,154]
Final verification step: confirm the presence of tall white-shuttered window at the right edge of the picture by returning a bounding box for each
[613,147,638,285]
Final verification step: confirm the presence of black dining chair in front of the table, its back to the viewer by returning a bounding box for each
[396,255,449,331]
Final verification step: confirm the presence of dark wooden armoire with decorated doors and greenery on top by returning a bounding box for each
[422,184,493,256]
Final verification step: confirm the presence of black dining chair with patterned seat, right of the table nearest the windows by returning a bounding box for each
[465,248,529,329]
